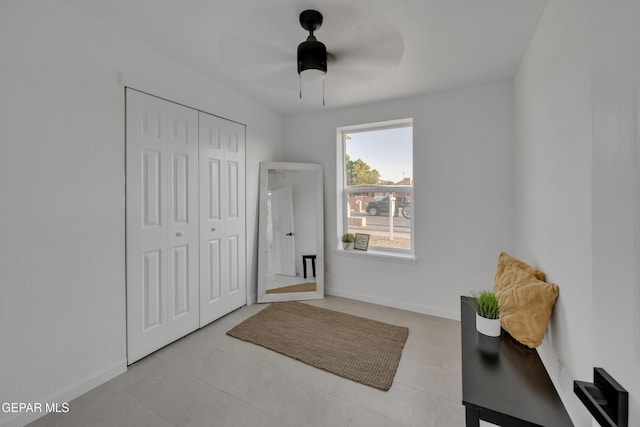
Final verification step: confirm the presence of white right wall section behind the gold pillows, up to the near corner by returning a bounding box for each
[513,0,593,425]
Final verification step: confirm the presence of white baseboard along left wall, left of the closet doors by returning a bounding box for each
[0,359,127,427]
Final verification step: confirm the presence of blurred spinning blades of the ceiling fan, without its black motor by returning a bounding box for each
[220,6,404,104]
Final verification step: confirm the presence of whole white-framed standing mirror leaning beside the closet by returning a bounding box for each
[258,162,324,302]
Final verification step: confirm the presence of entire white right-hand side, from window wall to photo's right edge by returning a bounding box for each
[514,0,640,426]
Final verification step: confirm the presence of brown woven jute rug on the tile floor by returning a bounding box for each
[227,302,409,391]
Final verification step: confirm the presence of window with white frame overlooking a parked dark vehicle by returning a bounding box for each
[337,119,414,258]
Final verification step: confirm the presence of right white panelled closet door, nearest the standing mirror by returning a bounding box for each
[199,112,246,326]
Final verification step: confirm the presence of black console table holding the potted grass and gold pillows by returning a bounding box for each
[460,297,573,427]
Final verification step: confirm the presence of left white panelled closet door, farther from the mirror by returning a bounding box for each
[126,89,199,363]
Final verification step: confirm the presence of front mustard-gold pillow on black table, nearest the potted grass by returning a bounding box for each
[496,270,559,348]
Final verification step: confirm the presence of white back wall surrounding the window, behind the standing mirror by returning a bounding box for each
[285,82,514,318]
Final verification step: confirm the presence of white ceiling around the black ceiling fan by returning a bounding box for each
[60,0,547,115]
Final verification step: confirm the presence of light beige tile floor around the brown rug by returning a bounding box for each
[30,296,464,427]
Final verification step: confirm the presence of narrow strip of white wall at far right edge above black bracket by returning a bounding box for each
[589,0,640,426]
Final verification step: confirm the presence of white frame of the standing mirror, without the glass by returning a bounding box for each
[257,161,324,303]
